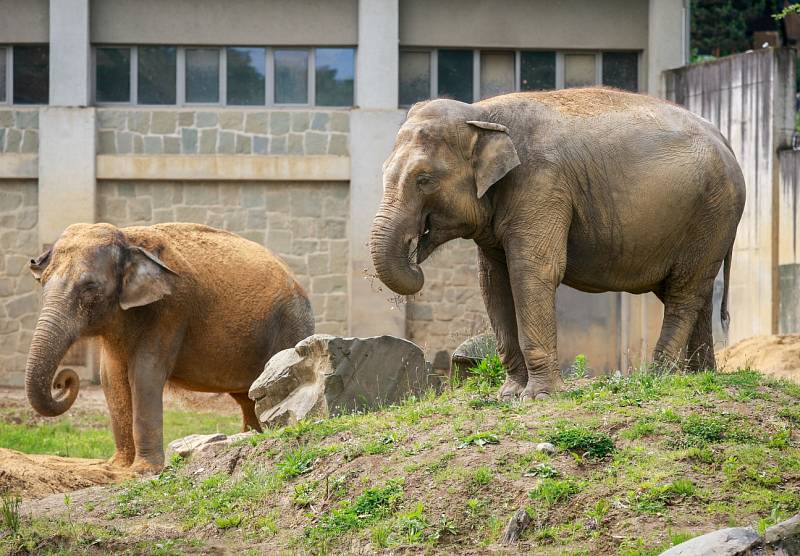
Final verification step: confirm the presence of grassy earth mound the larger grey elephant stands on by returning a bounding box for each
[0,362,800,556]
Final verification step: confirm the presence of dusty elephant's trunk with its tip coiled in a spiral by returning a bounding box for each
[25,300,80,417]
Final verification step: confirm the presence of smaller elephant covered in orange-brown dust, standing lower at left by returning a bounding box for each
[25,223,314,474]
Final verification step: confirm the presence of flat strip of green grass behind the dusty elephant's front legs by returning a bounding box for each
[0,410,241,458]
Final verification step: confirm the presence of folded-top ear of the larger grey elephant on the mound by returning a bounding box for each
[467,120,520,199]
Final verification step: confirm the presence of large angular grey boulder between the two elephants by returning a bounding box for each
[249,334,440,426]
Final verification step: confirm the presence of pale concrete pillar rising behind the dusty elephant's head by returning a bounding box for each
[39,0,97,244]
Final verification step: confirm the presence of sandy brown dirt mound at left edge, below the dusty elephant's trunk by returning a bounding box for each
[0,448,133,498]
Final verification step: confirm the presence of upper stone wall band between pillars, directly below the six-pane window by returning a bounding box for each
[97,108,350,156]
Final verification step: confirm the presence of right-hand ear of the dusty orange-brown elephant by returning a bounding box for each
[119,246,177,310]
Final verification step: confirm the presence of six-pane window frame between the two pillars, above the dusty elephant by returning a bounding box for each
[89,43,358,110]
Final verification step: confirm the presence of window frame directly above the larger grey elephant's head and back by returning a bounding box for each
[398,46,646,108]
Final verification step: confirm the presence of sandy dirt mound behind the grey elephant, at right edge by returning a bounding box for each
[717,334,800,382]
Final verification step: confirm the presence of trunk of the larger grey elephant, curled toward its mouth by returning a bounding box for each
[370,205,425,295]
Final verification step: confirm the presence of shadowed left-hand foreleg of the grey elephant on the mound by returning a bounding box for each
[478,249,528,400]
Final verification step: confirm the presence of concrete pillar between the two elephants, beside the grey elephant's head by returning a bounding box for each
[348,0,406,336]
